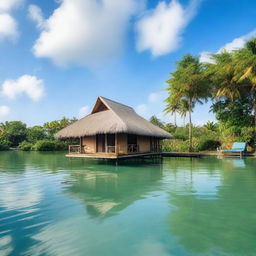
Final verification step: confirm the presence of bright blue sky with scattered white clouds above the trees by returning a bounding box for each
[0,0,256,125]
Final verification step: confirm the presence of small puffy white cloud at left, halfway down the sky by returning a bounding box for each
[1,75,44,101]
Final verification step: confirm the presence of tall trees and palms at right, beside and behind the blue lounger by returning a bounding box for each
[164,38,256,151]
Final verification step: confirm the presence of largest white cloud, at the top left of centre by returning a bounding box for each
[33,0,144,66]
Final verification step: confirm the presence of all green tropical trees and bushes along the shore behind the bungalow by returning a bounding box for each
[0,39,256,151]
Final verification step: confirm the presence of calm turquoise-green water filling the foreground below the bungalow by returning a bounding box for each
[0,152,256,256]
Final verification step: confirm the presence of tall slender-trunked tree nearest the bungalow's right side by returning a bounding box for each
[167,54,208,151]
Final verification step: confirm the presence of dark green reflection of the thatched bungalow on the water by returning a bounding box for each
[66,165,162,217]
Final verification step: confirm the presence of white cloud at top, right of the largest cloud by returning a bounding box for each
[136,0,199,56]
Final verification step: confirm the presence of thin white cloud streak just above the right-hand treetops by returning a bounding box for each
[199,29,256,63]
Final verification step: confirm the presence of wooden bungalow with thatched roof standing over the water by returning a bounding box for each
[55,97,172,159]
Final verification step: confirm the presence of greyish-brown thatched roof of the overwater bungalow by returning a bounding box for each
[55,97,172,139]
